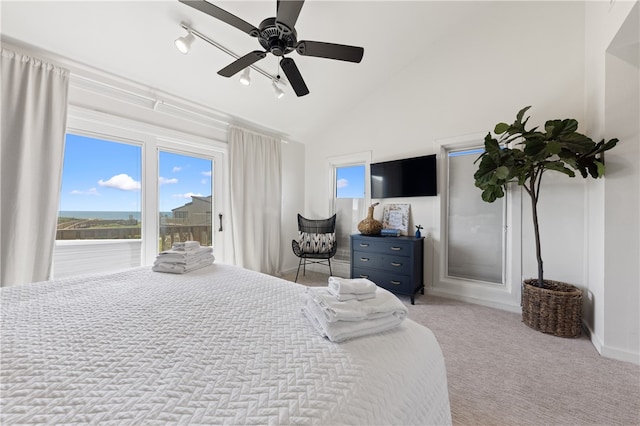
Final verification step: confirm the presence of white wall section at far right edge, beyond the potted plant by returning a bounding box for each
[585,1,640,363]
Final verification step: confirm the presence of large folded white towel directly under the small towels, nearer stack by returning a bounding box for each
[302,287,408,322]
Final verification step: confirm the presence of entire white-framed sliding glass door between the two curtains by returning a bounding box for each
[53,109,226,278]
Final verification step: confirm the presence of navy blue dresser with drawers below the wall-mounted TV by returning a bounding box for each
[351,234,424,305]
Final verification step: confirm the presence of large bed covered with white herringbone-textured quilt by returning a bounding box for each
[0,263,451,425]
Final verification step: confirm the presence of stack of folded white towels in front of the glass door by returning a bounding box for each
[151,241,215,274]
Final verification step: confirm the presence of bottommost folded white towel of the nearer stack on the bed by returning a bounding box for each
[302,301,404,343]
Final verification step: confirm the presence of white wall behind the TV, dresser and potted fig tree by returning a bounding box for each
[305,2,585,310]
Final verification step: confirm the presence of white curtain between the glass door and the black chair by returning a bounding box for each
[229,127,282,275]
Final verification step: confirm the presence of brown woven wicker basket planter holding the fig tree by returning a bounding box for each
[522,279,582,337]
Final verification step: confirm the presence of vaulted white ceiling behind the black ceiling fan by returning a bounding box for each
[0,0,490,142]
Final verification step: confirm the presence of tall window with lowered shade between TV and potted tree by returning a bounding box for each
[446,149,506,284]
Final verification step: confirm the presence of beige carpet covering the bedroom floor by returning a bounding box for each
[284,271,640,425]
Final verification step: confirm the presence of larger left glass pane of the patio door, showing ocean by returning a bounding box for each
[56,133,142,240]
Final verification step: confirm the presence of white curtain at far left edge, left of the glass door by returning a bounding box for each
[0,48,69,286]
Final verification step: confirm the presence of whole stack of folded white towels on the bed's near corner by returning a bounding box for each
[302,277,408,342]
